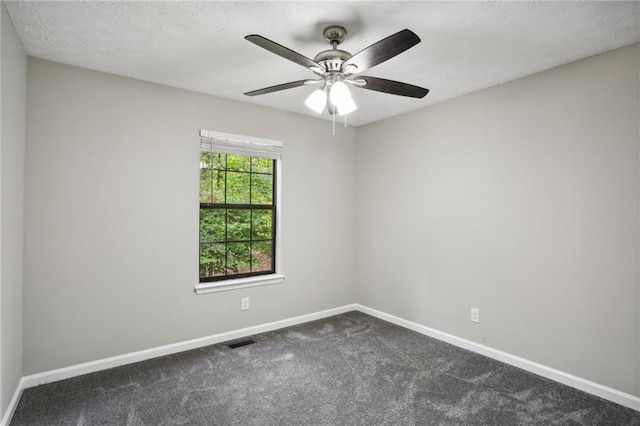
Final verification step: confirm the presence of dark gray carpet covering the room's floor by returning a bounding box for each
[11,312,640,426]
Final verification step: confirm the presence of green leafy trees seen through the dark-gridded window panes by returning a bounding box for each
[200,152,275,278]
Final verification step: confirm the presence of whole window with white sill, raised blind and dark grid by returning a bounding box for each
[196,130,283,293]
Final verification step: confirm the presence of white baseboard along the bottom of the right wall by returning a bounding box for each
[356,304,640,411]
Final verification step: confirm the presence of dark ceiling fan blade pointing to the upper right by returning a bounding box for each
[343,29,420,74]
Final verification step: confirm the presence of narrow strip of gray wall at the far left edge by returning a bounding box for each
[0,4,27,418]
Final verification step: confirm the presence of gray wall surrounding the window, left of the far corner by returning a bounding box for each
[24,58,356,374]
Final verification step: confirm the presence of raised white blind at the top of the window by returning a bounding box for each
[200,129,282,160]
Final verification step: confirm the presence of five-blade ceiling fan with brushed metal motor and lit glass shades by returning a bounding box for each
[245,25,429,115]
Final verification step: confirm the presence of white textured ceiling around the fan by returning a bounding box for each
[3,1,640,125]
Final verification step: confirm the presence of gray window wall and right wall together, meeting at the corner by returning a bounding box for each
[24,40,640,396]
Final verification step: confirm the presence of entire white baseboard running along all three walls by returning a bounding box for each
[0,303,640,426]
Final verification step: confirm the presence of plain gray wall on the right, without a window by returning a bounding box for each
[357,44,640,396]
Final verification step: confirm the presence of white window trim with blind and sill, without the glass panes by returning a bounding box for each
[195,129,284,294]
